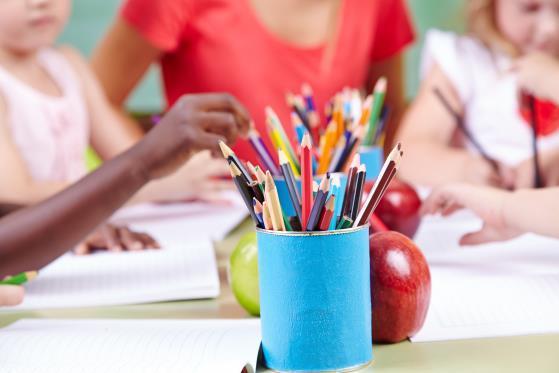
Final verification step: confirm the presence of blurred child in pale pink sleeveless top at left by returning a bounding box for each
[0,0,230,250]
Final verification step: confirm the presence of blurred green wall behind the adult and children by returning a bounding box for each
[60,0,465,112]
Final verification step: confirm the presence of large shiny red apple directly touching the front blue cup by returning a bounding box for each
[369,231,431,343]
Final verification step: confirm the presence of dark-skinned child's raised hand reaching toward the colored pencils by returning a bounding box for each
[139,94,250,179]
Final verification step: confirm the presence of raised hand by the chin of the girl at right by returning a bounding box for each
[512,52,559,103]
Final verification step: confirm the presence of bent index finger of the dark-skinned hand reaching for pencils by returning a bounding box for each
[189,93,250,135]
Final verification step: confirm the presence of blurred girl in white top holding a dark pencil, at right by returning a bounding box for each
[400,0,559,188]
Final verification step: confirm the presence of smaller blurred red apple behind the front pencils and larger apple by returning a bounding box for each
[365,179,421,238]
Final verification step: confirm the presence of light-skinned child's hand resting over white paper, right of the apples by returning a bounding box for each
[421,184,521,245]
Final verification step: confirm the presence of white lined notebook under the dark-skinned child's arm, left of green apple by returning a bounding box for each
[5,240,219,312]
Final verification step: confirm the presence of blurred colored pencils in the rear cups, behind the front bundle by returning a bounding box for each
[249,78,389,177]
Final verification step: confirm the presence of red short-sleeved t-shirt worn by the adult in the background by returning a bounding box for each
[121,0,414,162]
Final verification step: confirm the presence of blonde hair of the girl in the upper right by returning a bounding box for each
[466,0,519,56]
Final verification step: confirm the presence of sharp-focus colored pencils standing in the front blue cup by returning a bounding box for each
[220,133,403,231]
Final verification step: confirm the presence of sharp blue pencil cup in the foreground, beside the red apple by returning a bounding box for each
[257,226,373,372]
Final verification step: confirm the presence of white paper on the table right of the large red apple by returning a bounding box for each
[412,214,559,342]
